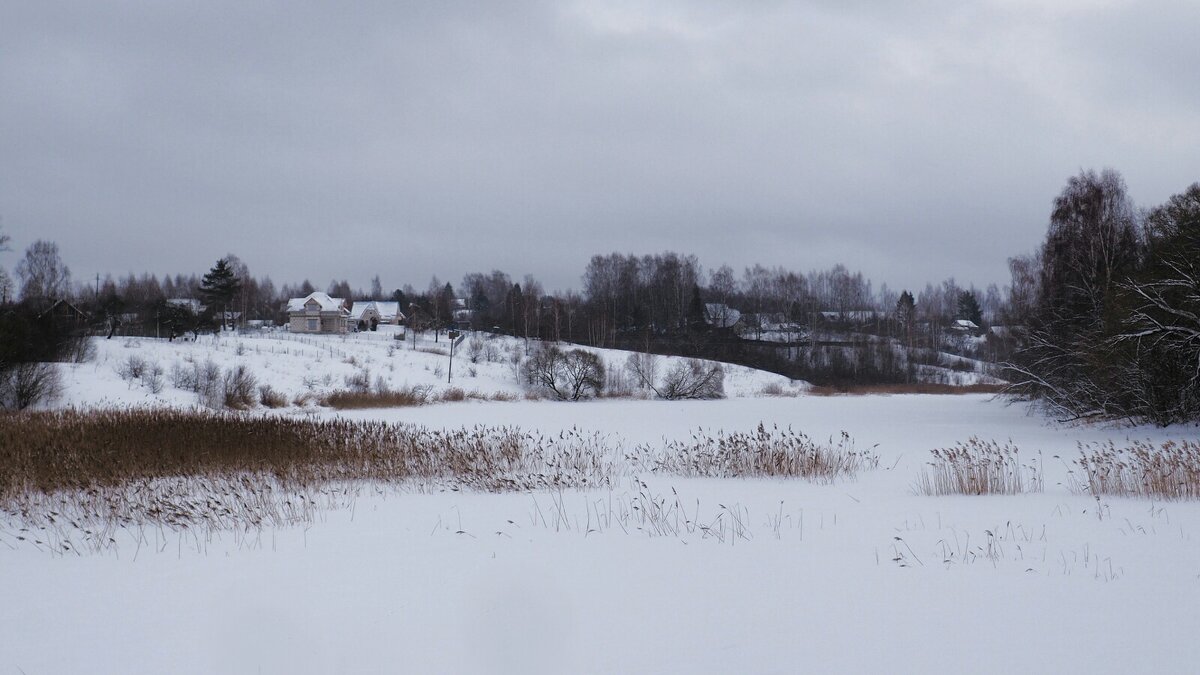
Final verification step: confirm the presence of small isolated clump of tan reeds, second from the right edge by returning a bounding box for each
[914,436,1044,495]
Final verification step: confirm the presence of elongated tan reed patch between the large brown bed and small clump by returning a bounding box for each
[634,424,880,483]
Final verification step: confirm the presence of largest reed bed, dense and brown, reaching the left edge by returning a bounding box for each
[0,410,618,550]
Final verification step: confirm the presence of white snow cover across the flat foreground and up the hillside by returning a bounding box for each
[0,335,1200,675]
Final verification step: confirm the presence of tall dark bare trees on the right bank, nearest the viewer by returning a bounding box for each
[1006,169,1200,424]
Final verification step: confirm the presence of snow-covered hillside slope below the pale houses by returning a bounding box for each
[55,325,806,407]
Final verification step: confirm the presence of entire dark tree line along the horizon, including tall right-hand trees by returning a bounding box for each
[0,169,1200,424]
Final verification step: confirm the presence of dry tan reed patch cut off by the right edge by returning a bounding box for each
[1075,441,1200,500]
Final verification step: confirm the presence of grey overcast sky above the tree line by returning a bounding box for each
[0,0,1200,289]
